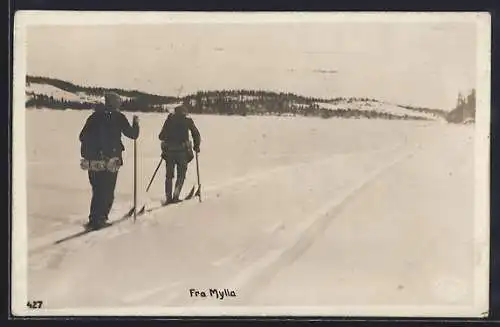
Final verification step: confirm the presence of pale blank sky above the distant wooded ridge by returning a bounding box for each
[27,22,476,110]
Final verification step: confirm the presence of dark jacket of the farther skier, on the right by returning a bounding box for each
[158,114,201,149]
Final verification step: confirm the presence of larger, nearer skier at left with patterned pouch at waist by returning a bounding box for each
[80,92,139,229]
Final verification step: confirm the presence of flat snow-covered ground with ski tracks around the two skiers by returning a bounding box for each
[21,110,474,314]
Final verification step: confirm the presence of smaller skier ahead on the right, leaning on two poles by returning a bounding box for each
[158,105,201,205]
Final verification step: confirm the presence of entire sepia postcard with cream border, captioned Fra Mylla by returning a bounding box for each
[11,11,491,317]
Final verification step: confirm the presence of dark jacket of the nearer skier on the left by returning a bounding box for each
[80,110,139,160]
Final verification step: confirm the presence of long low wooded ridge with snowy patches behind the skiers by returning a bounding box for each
[26,75,454,120]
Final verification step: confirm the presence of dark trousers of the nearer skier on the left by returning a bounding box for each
[89,171,118,222]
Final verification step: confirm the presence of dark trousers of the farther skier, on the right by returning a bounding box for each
[165,151,188,201]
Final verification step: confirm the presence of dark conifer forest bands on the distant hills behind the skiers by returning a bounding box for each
[26,76,431,120]
